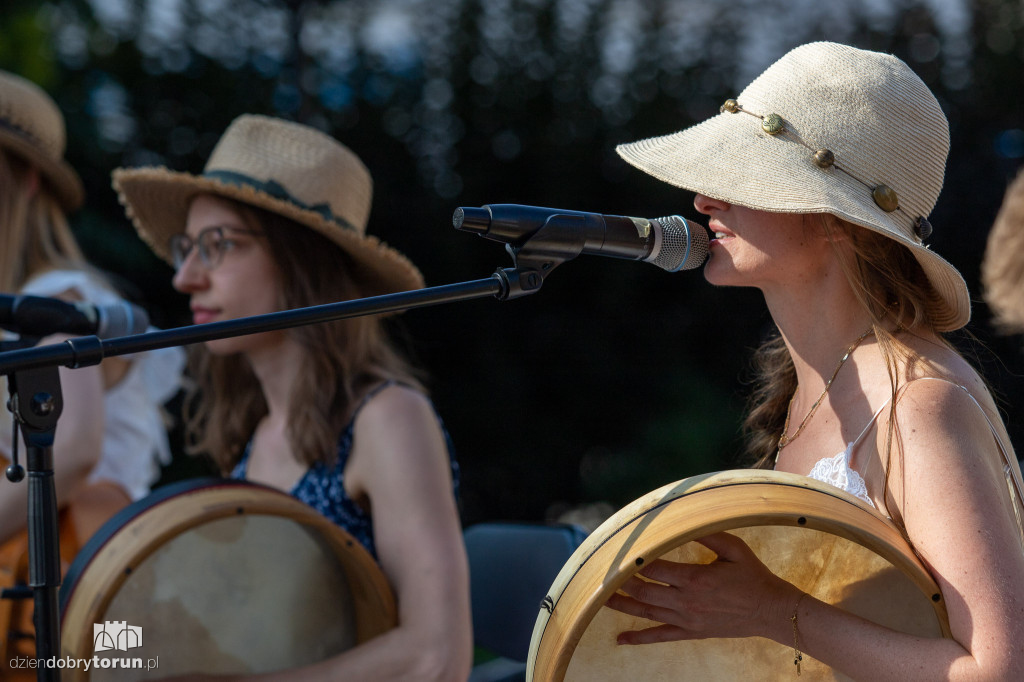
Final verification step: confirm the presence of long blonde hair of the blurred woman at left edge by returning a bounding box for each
[0,150,91,292]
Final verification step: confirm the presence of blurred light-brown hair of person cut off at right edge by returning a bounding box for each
[981,171,1024,333]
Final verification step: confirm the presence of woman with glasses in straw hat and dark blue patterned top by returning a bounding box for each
[114,116,471,680]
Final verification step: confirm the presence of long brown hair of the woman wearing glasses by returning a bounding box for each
[183,198,423,471]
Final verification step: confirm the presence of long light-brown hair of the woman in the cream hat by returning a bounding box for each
[743,214,942,518]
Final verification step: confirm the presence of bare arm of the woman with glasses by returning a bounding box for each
[184,386,472,682]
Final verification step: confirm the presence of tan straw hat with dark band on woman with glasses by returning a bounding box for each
[113,114,424,296]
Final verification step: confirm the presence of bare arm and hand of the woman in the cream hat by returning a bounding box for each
[608,381,1024,682]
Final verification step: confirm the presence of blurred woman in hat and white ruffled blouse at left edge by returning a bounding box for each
[0,67,184,665]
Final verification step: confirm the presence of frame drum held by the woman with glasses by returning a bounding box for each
[60,479,396,681]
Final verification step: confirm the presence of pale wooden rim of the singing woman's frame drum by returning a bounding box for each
[526,470,949,682]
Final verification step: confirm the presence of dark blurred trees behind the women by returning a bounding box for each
[0,0,1024,523]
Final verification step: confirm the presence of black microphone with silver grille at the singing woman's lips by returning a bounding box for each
[452,204,708,272]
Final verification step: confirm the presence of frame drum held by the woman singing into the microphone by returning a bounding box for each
[526,471,949,682]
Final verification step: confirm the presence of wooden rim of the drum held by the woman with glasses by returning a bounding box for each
[60,478,397,679]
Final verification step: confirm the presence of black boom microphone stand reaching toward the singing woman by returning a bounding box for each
[0,223,585,682]
